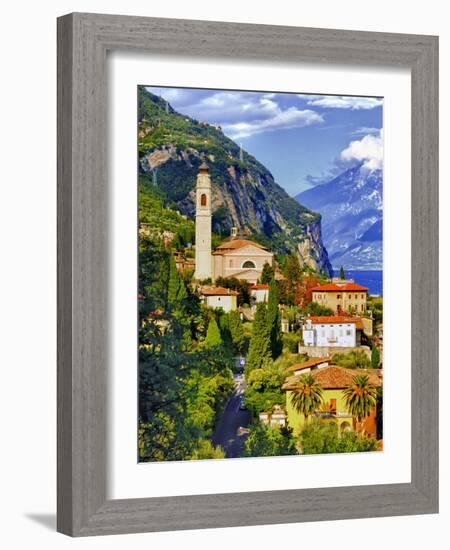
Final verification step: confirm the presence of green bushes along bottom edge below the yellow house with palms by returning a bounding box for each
[299,419,376,454]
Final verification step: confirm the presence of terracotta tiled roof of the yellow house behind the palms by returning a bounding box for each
[282,365,382,391]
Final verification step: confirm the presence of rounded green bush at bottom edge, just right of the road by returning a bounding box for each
[244,422,298,457]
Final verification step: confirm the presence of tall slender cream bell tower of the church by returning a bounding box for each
[194,162,212,280]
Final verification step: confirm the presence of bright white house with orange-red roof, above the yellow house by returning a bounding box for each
[303,316,363,348]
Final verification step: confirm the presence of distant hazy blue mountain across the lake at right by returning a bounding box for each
[296,164,383,269]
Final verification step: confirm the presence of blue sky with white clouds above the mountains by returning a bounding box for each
[148,87,383,196]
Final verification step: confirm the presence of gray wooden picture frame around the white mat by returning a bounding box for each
[57,13,438,536]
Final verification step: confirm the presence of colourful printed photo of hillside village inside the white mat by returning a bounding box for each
[137,85,383,462]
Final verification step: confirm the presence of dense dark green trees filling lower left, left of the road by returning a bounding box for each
[139,235,233,461]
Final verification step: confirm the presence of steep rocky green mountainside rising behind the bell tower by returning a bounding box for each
[139,87,331,273]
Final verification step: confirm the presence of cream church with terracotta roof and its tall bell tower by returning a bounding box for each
[194,162,273,284]
